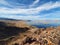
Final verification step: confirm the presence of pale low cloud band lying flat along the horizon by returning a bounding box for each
[0,15,60,20]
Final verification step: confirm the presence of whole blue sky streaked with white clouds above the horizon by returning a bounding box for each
[0,0,60,20]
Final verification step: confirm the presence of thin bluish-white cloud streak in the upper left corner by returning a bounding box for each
[0,0,29,8]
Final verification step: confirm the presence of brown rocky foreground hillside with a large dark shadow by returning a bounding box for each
[0,22,60,45]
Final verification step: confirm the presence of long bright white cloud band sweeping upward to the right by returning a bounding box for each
[0,2,60,15]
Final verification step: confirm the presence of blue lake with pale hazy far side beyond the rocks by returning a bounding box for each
[27,20,60,28]
